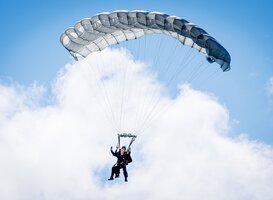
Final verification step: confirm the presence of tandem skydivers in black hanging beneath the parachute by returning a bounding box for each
[108,146,132,182]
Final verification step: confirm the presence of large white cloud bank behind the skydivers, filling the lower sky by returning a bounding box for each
[0,50,273,200]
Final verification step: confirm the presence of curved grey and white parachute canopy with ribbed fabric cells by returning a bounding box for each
[60,10,231,71]
